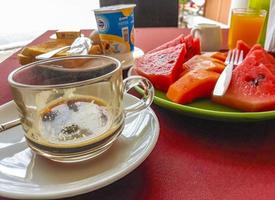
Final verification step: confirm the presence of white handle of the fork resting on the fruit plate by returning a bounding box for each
[213,64,234,96]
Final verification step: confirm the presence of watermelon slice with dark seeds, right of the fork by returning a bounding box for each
[212,45,275,111]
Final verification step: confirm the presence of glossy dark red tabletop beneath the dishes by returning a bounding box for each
[0,28,275,200]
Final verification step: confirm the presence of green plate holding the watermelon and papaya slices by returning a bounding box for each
[128,68,275,122]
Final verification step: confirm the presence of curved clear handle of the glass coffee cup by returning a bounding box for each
[123,76,155,114]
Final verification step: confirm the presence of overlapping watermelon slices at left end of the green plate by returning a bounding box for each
[135,34,200,92]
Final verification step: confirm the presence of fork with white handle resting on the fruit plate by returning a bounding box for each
[213,49,243,96]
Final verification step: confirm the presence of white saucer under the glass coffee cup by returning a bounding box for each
[0,95,159,199]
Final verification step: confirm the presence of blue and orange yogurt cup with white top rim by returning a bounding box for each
[94,4,136,56]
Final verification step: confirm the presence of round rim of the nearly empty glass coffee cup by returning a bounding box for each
[8,55,122,90]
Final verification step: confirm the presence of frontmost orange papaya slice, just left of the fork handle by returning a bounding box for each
[166,69,220,104]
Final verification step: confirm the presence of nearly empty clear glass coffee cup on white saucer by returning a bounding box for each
[8,56,154,162]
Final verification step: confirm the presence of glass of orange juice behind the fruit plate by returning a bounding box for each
[228,8,267,49]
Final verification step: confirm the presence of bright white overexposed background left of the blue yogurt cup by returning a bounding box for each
[0,0,99,62]
